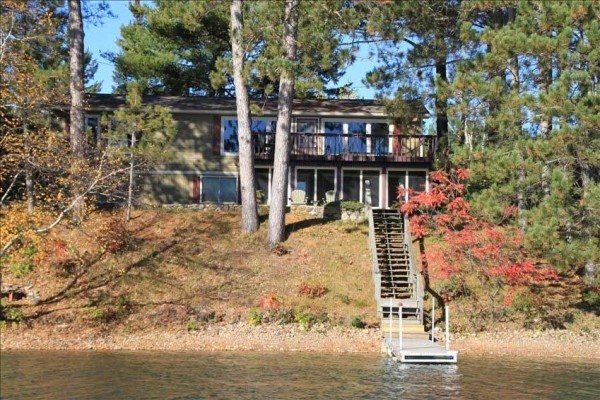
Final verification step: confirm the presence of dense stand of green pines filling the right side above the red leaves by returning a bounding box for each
[450,1,600,284]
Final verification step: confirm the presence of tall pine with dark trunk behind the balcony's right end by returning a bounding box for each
[364,0,461,167]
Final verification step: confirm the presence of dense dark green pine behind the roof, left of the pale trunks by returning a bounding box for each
[105,0,233,96]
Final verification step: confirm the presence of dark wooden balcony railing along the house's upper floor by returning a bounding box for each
[253,133,436,163]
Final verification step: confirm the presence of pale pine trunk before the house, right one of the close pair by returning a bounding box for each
[268,0,299,248]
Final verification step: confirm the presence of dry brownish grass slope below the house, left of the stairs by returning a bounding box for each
[2,210,376,330]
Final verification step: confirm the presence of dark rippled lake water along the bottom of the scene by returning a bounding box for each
[0,351,600,400]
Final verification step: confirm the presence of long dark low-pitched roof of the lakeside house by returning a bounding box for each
[87,94,428,117]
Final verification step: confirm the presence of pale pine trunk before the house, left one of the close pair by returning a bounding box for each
[231,0,258,233]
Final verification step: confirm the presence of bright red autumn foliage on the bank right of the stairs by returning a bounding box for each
[399,169,557,326]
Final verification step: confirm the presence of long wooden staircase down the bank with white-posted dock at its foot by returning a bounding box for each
[365,191,458,364]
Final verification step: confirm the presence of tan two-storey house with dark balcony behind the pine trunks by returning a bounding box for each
[86,94,436,208]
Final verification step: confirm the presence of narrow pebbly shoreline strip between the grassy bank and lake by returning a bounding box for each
[0,322,600,359]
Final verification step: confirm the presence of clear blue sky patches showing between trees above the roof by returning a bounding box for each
[84,0,375,99]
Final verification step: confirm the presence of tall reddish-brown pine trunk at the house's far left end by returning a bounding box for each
[69,0,85,223]
